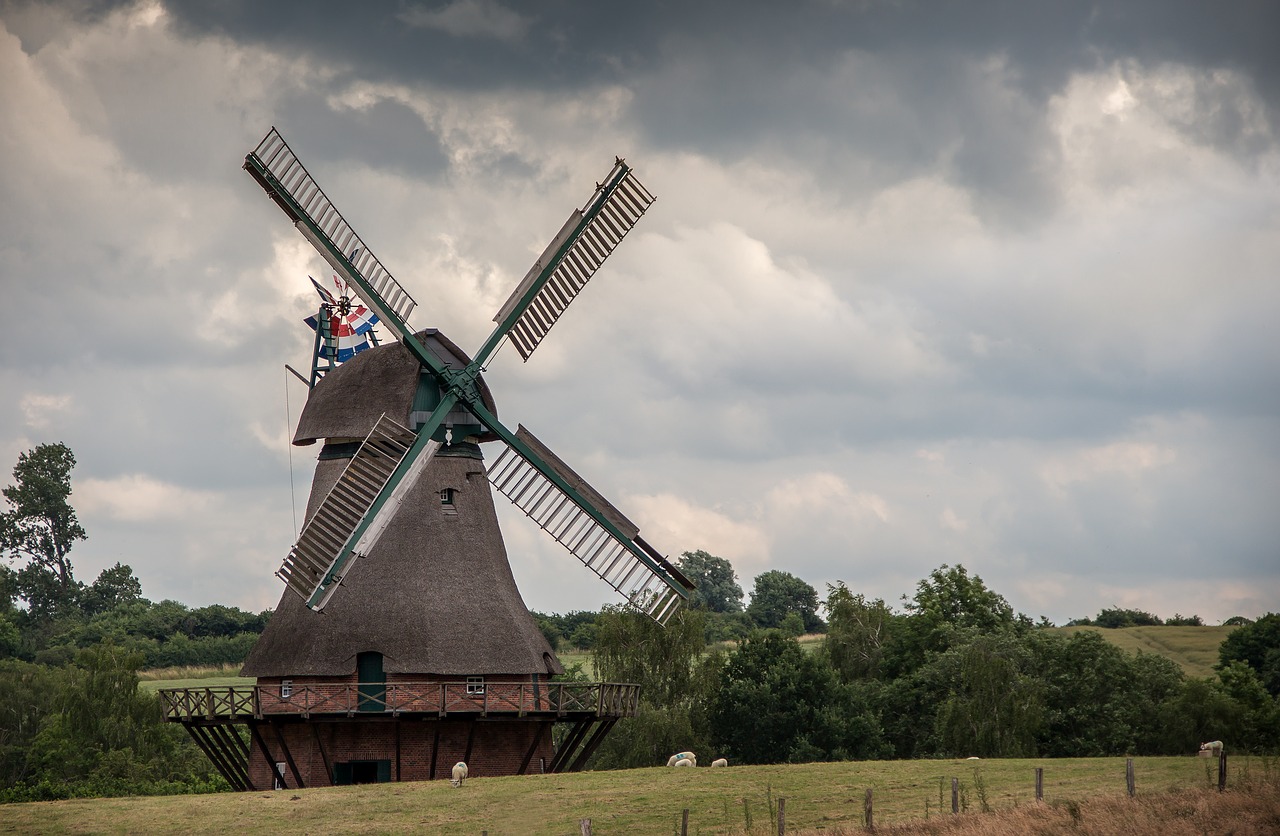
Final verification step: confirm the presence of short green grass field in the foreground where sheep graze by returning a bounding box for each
[0,757,1280,836]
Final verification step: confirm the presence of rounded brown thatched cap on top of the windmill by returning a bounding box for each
[293,328,498,447]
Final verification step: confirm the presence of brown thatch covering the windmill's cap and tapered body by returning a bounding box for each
[243,332,563,676]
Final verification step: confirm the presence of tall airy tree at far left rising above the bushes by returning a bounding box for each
[0,443,86,618]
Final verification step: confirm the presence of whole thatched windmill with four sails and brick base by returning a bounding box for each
[164,128,692,789]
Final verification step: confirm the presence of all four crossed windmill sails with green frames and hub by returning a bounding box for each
[244,128,692,623]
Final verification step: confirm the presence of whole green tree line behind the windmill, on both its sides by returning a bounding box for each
[0,444,1280,801]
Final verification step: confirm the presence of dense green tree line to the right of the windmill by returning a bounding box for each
[578,553,1280,768]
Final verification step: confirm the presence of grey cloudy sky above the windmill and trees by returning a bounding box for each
[0,0,1280,623]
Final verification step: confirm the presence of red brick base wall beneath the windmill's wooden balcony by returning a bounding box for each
[250,717,553,790]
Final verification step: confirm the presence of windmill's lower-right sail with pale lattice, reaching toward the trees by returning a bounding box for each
[489,426,692,623]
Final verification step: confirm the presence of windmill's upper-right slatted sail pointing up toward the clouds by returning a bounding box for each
[480,159,654,361]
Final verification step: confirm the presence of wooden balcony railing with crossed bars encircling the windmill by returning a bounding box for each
[160,680,640,722]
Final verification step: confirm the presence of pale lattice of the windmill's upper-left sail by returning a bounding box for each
[244,128,417,324]
